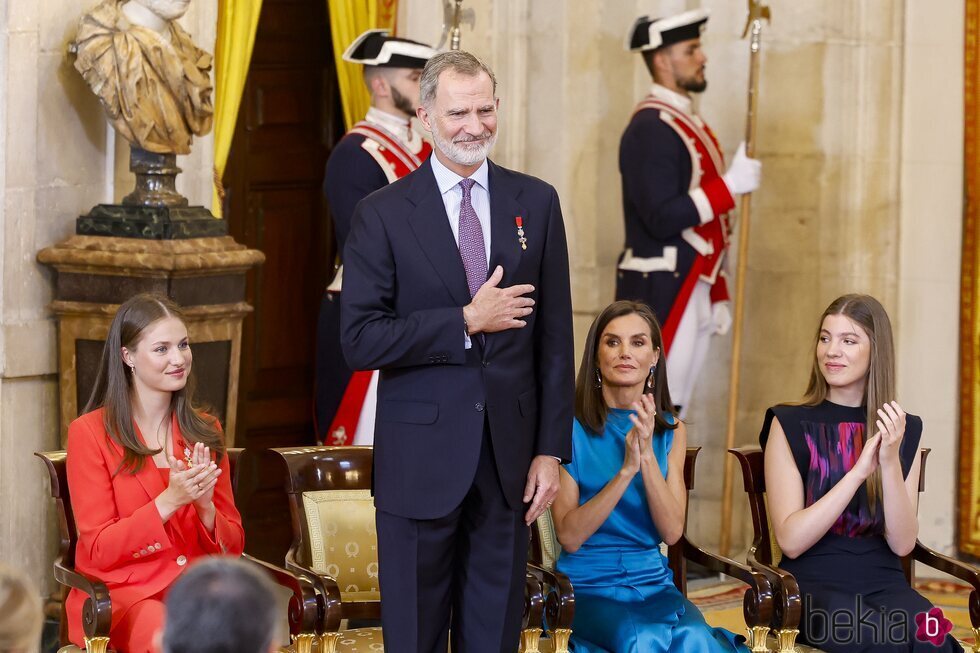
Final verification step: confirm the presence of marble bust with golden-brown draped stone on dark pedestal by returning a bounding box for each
[75,0,214,154]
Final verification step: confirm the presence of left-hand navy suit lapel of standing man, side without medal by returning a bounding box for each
[408,164,470,306]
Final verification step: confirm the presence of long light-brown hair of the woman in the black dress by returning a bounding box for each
[801,294,895,515]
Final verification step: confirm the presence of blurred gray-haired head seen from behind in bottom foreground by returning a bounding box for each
[162,556,285,653]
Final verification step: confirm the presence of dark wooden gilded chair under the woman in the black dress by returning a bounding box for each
[728,447,980,653]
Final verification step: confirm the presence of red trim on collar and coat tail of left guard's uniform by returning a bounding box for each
[324,120,432,445]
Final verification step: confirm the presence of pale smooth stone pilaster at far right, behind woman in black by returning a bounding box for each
[892,0,964,553]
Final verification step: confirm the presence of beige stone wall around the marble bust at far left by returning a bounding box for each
[0,0,217,589]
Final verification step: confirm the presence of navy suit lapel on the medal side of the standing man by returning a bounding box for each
[485,161,528,354]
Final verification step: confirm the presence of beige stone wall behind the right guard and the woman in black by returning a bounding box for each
[399,0,963,550]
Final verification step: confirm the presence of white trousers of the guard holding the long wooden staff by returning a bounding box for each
[667,279,715,419]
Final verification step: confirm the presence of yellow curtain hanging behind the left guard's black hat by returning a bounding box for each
[327,0,398,129]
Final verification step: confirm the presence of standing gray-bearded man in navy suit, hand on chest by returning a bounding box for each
[341,51,574,653]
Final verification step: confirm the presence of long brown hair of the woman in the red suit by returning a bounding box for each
[84,293,225,474]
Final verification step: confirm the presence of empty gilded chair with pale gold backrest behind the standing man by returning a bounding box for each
[271,446,544,653]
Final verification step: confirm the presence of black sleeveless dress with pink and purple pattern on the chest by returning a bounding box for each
[759,401,963,653]
